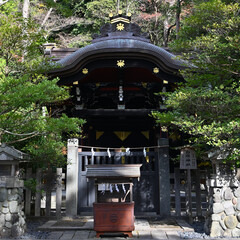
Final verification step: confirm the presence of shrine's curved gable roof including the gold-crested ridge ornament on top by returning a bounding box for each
[50,13,187,77]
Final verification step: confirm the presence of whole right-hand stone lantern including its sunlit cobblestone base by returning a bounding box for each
[204,148,240,238]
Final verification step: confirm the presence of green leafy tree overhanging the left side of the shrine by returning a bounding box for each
[0,10,85,166]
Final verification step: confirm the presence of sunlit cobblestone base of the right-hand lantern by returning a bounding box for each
[205,186,240,237]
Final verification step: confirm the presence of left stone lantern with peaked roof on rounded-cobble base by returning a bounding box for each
[0,143,28,238]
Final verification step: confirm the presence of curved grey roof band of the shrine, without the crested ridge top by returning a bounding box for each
[51,38,188,74]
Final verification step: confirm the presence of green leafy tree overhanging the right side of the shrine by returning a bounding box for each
[153,0,240,163]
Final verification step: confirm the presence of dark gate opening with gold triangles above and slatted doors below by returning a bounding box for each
[78,113,159,214]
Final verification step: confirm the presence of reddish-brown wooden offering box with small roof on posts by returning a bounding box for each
[87,164,141,237]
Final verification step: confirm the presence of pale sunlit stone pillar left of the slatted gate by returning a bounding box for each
[66,138,79,217]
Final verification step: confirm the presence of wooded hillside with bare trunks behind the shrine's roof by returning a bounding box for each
[1,0,196,47]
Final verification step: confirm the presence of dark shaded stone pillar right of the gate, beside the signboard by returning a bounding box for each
[158,138,170,217]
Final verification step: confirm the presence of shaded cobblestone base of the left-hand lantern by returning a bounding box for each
[0,187,26,238]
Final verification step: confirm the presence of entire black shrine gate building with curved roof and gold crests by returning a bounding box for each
[47,11,186,215]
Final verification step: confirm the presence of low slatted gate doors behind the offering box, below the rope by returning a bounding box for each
[78,151,159,214]
